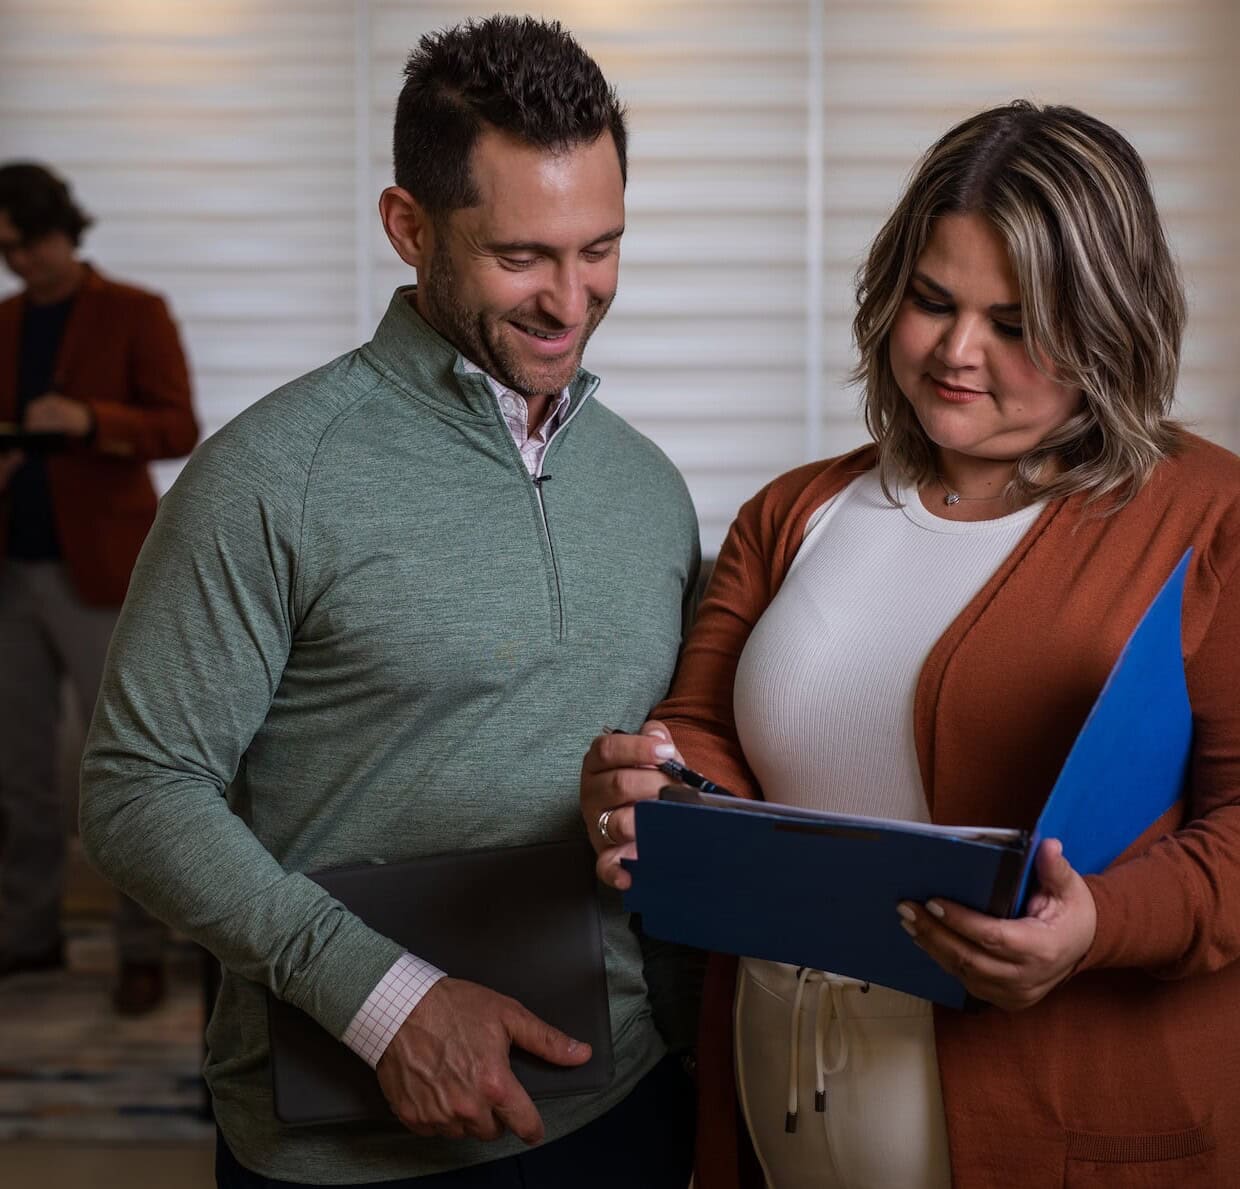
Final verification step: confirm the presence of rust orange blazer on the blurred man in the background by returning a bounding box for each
[0,267,198,606]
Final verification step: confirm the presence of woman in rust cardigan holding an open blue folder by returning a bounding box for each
[582,103,1240,1189]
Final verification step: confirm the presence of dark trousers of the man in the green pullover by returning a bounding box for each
[216,1056,694,1189]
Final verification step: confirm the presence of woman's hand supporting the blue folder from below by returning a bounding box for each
[899,838,1097,1012]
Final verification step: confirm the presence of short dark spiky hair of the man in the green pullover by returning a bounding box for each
[393,16,627,214]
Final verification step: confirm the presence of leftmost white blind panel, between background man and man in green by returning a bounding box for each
[0,0,357,493]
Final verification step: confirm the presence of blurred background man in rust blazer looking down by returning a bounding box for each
[0,164,198,1014]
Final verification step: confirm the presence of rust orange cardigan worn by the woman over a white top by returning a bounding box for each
[655,435,1240,1189]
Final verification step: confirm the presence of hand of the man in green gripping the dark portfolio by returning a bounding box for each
[376,978,590,1143]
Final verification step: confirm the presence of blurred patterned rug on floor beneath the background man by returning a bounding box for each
[0,924,213,1143]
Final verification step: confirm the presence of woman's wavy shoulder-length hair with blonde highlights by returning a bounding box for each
[852,100,1185,511]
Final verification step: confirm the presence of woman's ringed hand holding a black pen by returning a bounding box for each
[582,722,681,891]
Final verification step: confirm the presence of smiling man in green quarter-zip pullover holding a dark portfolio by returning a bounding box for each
[82,17,698,1189]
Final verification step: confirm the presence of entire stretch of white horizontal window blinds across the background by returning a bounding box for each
[0,0,1240,552]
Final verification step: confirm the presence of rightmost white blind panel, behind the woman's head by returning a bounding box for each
[822,0,1240,493]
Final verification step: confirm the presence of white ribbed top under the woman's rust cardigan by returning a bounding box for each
[734,471,1042,822]
